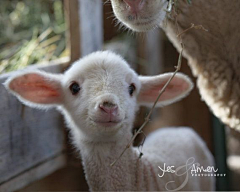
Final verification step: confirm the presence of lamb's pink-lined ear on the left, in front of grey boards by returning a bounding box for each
[4,71,63,108]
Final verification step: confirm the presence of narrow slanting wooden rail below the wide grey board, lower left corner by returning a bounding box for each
[0,154,66,192]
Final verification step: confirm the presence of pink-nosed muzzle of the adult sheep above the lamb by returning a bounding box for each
[111,0,167,32]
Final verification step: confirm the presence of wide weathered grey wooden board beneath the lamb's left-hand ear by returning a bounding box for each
[0,63,66,188]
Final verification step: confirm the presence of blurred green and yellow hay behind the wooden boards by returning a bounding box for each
[0,0,69,73]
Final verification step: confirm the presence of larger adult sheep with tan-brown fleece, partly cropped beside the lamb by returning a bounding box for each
[111,0,240,131]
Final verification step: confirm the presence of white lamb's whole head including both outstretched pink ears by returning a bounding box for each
[5,51,193,142]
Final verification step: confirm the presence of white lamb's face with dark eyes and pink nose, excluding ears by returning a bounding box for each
[62,52,140,137]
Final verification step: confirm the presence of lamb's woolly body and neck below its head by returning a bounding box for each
[78,128,215,191]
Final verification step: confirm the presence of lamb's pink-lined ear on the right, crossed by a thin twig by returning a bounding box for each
[138,73,193,107]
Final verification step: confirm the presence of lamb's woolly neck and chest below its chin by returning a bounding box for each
[80,134,138,191]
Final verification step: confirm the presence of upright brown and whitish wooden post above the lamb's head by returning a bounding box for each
[64,0,103,62]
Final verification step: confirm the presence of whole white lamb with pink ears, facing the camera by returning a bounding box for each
[5,51,214,191]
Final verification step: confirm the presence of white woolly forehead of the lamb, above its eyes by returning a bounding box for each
[65,51,137,80]
